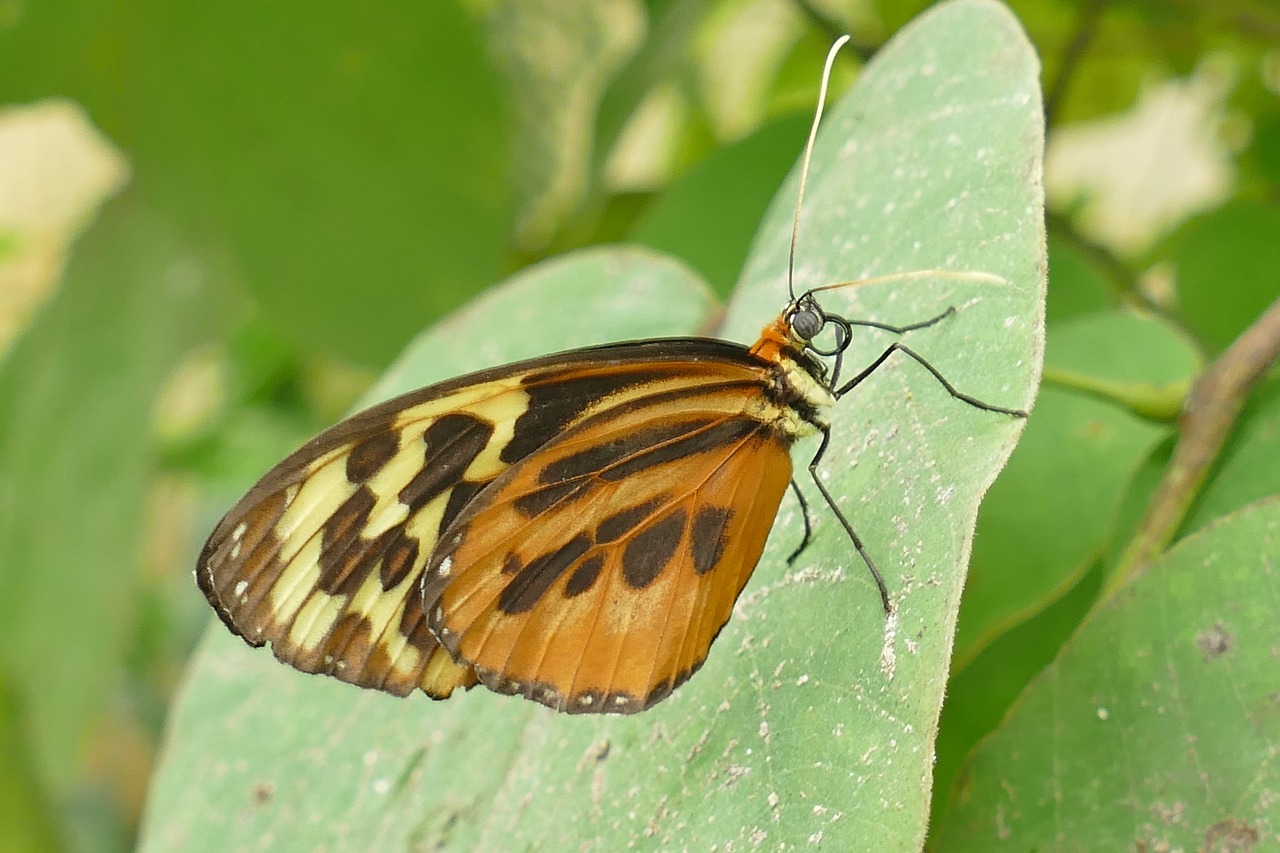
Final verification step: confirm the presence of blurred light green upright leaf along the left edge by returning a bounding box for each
[0,196,218,795]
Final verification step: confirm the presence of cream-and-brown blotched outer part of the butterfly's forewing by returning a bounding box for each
[197,378,529,697]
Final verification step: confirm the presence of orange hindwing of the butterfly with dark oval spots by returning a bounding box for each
[422,364,791,713]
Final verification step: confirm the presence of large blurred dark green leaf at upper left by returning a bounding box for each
[0,0,508,366]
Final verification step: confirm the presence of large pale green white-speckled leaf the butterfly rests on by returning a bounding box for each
[143,0,1044,849]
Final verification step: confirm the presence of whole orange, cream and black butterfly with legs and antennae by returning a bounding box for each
[196,42,1024,713]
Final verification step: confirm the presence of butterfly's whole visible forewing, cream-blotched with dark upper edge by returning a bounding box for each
[196,338,788,698]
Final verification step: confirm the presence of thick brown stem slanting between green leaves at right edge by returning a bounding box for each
[1102,300,1280,599]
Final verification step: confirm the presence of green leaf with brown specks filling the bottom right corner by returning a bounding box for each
[936,498,1280,852]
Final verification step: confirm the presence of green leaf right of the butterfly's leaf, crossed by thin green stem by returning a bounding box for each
[955,311,1198,670]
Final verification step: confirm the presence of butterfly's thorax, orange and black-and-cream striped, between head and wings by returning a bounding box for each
[750,314,836,441]
